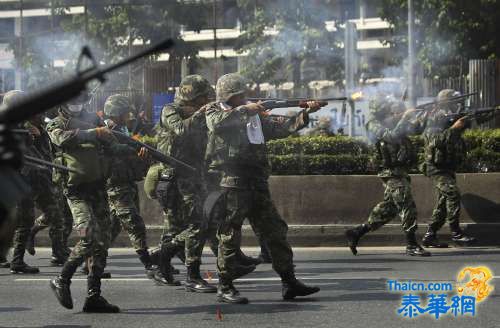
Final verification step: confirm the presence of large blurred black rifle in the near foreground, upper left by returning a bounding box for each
[0,39,174,213]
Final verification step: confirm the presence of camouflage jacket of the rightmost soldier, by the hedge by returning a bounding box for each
[422,110,466,176]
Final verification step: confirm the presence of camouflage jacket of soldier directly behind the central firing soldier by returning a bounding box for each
[157,102,207,178]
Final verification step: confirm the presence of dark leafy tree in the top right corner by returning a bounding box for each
[380,0,500,77]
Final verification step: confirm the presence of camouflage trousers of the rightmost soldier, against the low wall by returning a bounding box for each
[430,174,461,232]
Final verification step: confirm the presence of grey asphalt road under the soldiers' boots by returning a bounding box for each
[0,247,500,328]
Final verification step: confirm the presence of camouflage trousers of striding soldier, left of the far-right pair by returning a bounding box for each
[368,176,417,232]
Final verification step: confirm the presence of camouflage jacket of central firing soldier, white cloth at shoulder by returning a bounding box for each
[206,103,309,187]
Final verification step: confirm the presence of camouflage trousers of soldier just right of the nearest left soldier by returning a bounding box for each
[107,182,148,250]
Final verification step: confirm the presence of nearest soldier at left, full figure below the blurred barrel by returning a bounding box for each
[47,98,120,313]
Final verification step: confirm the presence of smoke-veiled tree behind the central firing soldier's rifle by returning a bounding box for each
[235,0,343,86]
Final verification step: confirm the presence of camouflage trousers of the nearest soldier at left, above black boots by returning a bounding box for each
[61,182,110,281]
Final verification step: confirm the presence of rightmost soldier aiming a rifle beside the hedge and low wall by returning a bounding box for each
[422,89,475,248]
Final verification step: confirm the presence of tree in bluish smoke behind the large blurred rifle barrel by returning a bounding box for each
[11,0,208,88]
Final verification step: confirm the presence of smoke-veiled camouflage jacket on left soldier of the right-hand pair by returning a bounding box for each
[366,114,420,178]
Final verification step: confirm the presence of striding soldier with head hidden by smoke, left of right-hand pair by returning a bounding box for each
[346,96,431,256]
